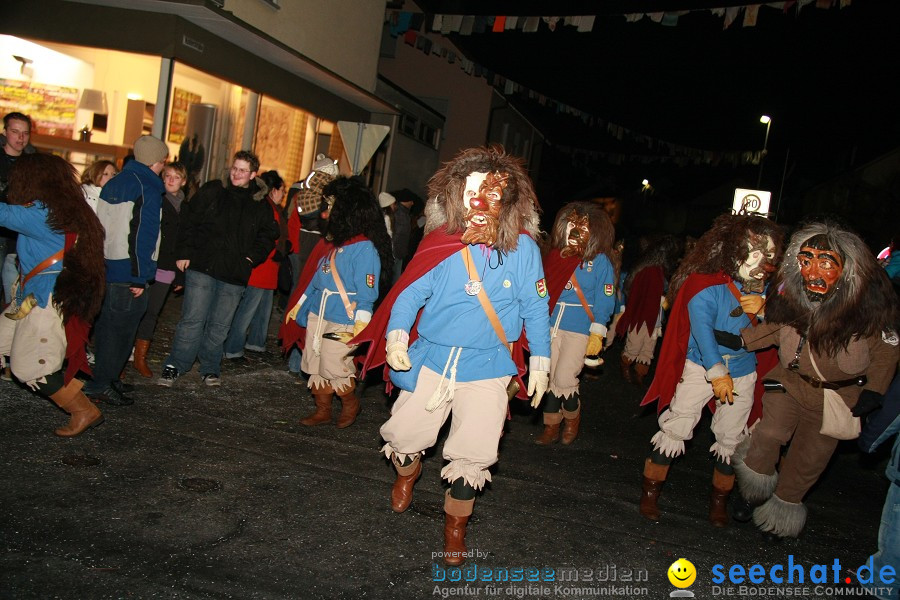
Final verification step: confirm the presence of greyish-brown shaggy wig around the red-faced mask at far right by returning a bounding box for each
[766,220,898,356]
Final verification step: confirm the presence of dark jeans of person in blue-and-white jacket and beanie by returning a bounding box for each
[84,283,147,394]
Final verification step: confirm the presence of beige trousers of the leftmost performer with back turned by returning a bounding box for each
[0,296,66,390]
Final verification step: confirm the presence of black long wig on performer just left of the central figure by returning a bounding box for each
[322,176,394,294]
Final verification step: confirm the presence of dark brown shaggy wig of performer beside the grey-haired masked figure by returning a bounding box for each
[666,213,784,306]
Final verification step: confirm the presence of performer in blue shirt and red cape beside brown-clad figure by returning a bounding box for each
[640,214,782,527]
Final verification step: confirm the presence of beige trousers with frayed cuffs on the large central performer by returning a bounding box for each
[381,366,510,489]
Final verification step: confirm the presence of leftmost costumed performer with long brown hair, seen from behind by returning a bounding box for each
[0,153,106,437]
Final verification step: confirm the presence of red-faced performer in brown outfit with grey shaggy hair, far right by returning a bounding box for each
[734,221,898,541]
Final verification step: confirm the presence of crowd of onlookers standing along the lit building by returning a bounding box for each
[0,113,424,405]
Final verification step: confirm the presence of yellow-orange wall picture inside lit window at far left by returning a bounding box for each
[0,79,78,139]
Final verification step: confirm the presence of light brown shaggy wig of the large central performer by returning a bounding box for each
[425,145,540,252]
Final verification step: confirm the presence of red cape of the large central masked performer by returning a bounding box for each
[350,227,525,393]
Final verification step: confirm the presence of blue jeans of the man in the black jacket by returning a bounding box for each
[164,269,244,375]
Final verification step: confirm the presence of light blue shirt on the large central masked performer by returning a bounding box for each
[387,234,550,382]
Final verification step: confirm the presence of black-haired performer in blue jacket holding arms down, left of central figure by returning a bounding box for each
[292,177,393,429]
